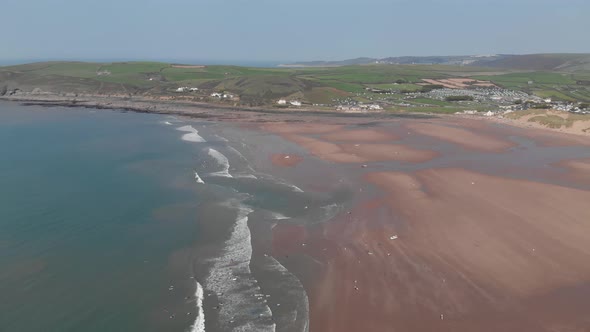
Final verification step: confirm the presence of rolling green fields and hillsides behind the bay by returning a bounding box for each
[0,62,590,112]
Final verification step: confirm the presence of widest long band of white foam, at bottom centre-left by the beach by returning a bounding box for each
[205,202,276,331]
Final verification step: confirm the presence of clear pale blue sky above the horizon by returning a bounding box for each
[0,0,590,61]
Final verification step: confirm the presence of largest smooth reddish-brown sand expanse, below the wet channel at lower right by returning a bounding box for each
[300,169,590,331]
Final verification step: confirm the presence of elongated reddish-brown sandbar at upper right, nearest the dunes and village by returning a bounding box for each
[406,122,513,151]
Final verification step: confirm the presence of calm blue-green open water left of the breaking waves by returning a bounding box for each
[0,103,199,332]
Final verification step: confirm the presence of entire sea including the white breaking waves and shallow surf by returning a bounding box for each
[0,103,320,332]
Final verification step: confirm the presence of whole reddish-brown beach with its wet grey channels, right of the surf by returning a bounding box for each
[262,118,590,331]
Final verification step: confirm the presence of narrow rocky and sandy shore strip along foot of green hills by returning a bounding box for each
[0,94,590,140]
